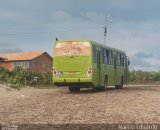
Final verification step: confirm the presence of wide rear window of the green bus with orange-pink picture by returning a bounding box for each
[55,42,91,56]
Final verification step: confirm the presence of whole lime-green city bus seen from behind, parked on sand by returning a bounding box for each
[53,40,129,92]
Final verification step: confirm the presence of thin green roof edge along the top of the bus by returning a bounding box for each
[56,40,126,54]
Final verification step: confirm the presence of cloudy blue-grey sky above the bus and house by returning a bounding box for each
[0,0,160,71]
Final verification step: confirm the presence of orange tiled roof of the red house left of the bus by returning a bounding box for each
[0,52,46,61]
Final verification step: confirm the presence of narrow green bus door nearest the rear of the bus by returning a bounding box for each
[96,51,101,86]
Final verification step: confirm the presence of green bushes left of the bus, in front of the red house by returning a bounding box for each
[0,67,53,89]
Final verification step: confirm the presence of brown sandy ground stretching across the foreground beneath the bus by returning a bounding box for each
[0,85,160,128]
